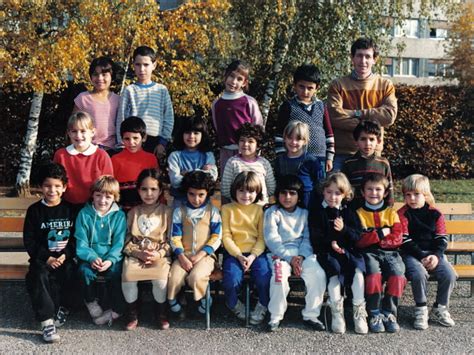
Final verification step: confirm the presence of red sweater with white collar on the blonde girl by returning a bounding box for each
[53,144,114,204]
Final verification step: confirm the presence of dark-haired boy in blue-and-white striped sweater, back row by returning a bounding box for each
[117,46,174,156]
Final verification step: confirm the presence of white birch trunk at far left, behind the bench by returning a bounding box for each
[16,92,43,197]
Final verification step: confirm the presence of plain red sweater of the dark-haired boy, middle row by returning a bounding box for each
[112,149,158,183]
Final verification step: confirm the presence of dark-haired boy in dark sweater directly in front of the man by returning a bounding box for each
[342,120,393,209]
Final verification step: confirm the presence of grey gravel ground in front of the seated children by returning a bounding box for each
[0,282,474,354]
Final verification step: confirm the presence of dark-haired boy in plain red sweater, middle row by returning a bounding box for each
[111,116,158,211]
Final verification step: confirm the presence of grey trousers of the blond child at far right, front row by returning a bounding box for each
[403,255,457,306]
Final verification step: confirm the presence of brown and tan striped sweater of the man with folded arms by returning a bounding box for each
[328,74,397,154]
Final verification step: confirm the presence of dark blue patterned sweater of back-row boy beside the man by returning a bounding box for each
[277,96,334,160]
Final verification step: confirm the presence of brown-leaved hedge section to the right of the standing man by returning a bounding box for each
[386,85,473,179]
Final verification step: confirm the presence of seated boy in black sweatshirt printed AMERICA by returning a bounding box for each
[23,163,76,343]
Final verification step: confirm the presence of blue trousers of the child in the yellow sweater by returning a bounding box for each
[222,253,272,309]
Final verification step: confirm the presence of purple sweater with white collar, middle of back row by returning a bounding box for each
[212,92,263,147]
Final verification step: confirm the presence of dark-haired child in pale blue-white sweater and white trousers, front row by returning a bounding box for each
[263,175,326,332]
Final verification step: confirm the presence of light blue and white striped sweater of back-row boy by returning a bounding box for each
[117,82,174,145]
